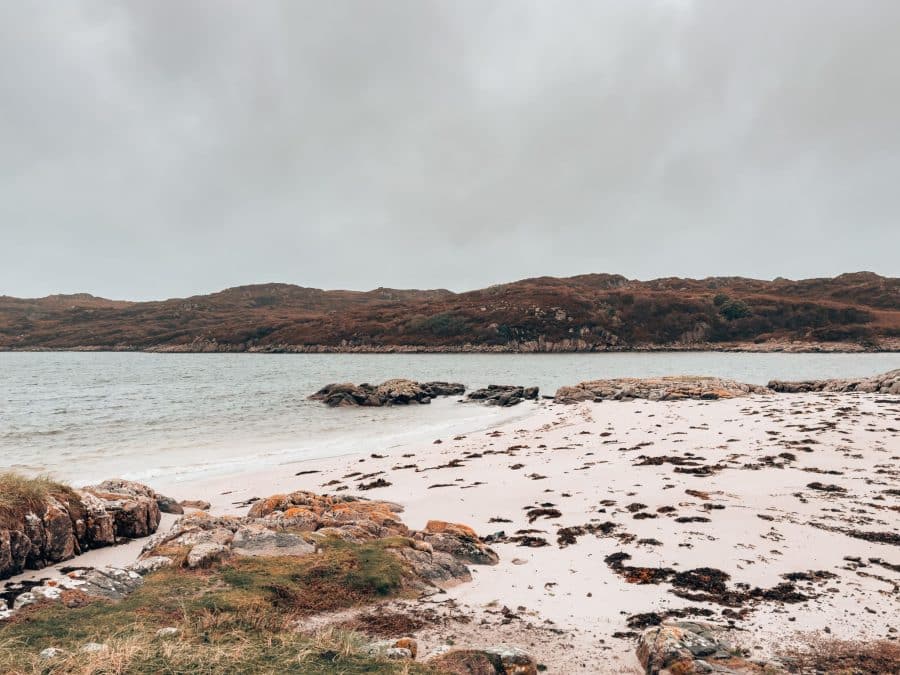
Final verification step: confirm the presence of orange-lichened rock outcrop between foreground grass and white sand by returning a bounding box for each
[141,491,499,590]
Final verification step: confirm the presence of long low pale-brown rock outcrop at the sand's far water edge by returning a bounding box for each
[554,376,771,403]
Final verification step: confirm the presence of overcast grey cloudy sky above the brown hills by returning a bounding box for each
[0,0,900,299]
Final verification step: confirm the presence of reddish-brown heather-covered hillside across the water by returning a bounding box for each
[0,272,900,351]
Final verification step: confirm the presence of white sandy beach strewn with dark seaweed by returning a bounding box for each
[8,393,900,673]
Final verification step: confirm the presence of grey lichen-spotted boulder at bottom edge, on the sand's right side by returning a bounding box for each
[637,621,787,675]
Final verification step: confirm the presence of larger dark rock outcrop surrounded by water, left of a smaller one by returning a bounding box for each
[309,379,466,408]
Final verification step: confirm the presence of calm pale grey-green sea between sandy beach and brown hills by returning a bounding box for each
[0,352,900,484]
